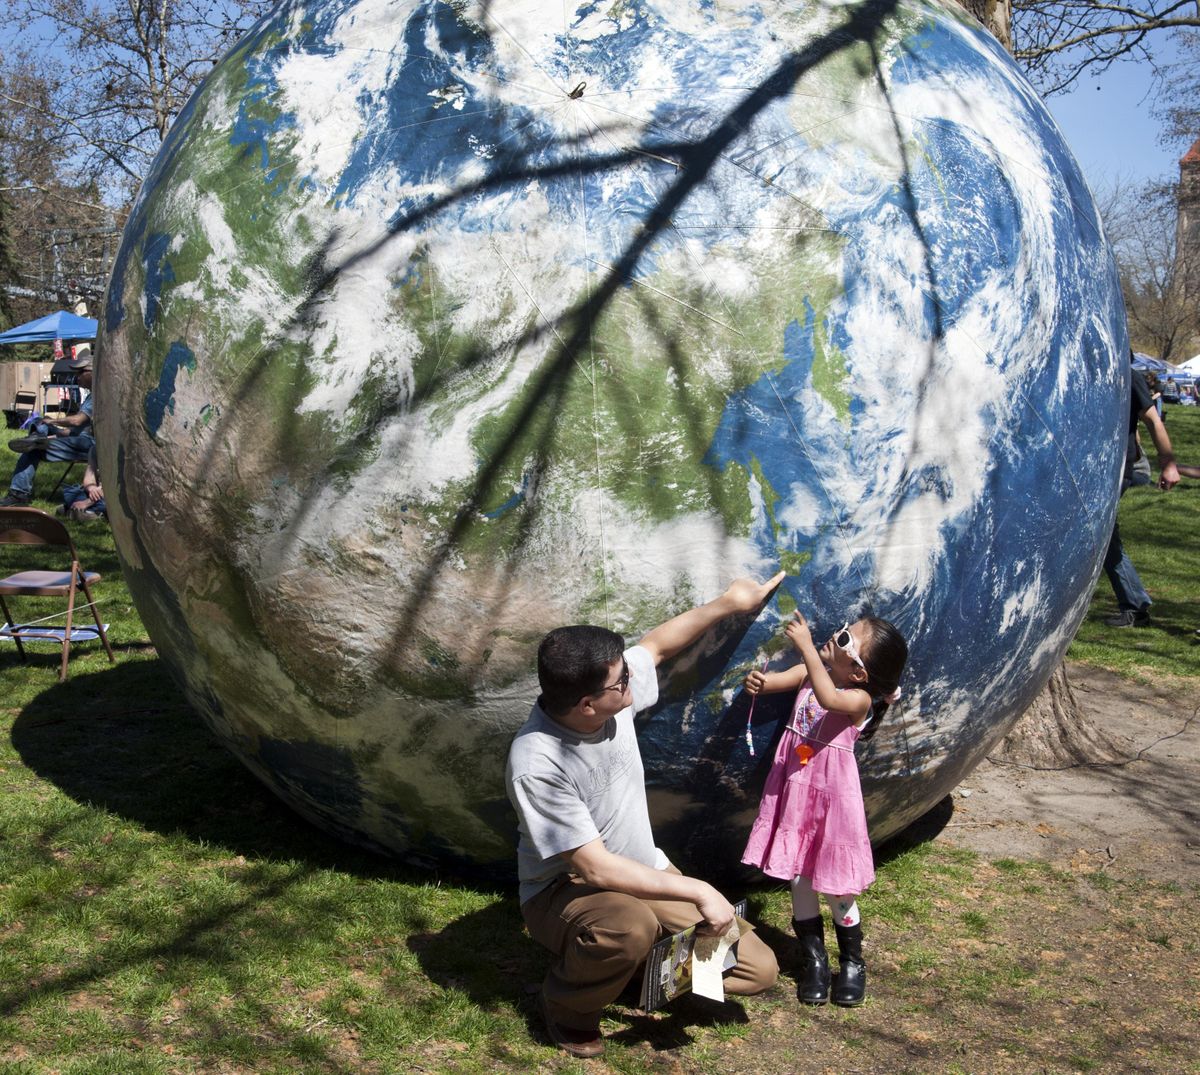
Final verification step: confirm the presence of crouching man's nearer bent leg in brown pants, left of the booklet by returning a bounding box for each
[521,877,659,1044]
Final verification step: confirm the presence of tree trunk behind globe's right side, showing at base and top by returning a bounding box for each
[959,0,1121,769]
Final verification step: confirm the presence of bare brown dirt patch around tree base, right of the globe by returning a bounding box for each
[937,665,1200,883]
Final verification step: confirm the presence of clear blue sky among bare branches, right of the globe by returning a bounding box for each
[1045,49,1187,191]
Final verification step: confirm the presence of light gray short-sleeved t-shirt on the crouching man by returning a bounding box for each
[505,645,667,903]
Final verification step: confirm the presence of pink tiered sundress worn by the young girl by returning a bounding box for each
[742,685,875,896]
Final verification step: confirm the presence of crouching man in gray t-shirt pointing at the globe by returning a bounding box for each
[506,572,784,1057]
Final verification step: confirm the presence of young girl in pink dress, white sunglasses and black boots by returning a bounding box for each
[742,612,908,1008]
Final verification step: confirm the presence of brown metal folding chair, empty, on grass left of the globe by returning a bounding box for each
[0,508,115,683]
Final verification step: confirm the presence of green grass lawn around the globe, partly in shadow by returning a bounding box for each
[0,408,1200,1075]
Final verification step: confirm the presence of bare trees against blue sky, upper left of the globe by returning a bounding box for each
[0,0,269,320]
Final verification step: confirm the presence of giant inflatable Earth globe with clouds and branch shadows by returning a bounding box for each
[97,0,1128,875]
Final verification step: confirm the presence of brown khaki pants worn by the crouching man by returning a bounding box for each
[521,866,779,1031]
